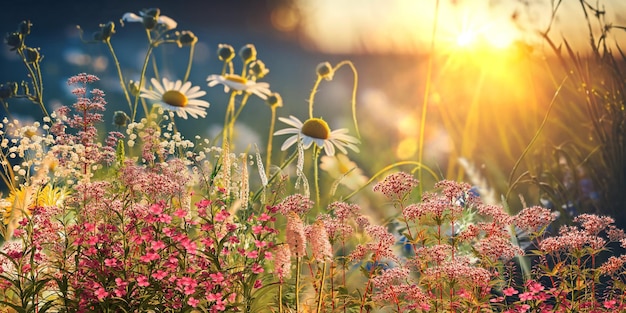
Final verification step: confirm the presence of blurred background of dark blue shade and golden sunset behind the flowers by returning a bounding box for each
[0,0,626,227]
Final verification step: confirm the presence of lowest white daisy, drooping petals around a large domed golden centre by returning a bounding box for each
[274,116,359,156]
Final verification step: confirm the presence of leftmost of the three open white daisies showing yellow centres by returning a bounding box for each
[139,78,209,119]
